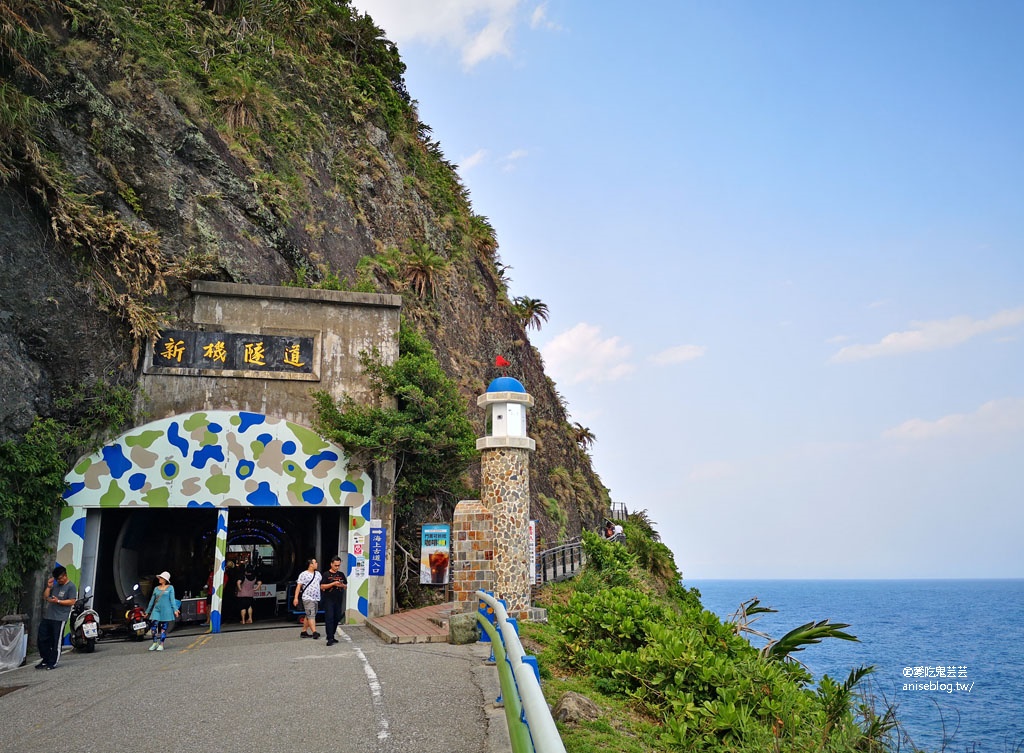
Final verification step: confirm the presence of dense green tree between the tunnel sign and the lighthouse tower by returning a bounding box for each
[315,322,477,516]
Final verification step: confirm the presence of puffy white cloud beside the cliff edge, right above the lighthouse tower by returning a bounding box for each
[542,322,636,384]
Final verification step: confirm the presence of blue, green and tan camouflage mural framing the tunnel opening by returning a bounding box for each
[56,411,372,632]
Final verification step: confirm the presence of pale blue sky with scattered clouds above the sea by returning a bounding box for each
[353,0,1024,580]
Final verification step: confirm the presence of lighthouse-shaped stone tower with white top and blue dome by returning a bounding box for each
[476,377,537,619]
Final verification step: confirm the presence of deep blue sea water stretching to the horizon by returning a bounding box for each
[683,580,1024,753]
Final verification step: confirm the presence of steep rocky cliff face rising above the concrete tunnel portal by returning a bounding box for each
[0,0,607,542]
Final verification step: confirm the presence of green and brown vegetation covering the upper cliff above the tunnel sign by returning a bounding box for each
[0,0,498,342]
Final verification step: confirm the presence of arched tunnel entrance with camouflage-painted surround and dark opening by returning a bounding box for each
[54,411,376,632]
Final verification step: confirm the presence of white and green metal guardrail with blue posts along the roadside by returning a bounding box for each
[476,591,565,753]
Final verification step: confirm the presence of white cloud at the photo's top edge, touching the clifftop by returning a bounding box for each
[353,0,519,68]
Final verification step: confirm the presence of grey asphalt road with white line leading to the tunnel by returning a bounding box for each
[0,625,511,753]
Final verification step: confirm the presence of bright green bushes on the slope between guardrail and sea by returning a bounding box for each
[523,521,895,753]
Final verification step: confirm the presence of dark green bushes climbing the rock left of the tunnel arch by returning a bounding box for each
[0,380,133,614]
